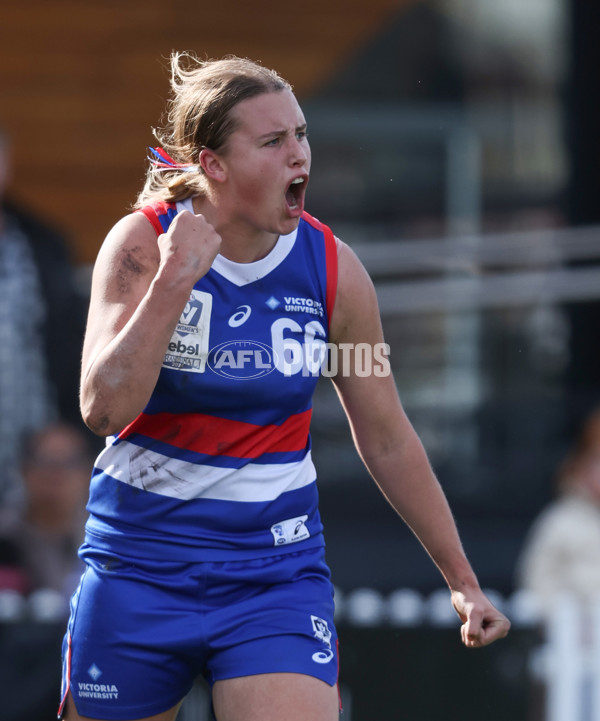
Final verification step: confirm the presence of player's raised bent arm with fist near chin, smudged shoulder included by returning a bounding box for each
[80,211,221,436]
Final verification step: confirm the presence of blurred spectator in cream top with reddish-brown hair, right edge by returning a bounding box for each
[517,410,600,610]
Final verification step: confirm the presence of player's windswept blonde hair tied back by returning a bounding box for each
[134,52,292,208]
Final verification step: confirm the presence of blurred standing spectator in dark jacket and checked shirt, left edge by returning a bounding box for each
[0,129,86,504]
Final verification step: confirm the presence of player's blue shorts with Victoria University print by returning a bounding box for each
[59,547,338,719]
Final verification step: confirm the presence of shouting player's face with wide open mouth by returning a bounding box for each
[218,90,311,234]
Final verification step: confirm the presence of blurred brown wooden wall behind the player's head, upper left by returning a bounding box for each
[0,0,410,263]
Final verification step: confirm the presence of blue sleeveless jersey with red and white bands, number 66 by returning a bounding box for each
[86,201,337,561]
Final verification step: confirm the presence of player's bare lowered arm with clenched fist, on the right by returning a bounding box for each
[330,243,510,647]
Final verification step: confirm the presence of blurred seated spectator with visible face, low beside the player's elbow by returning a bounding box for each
[0,423,93,608]
